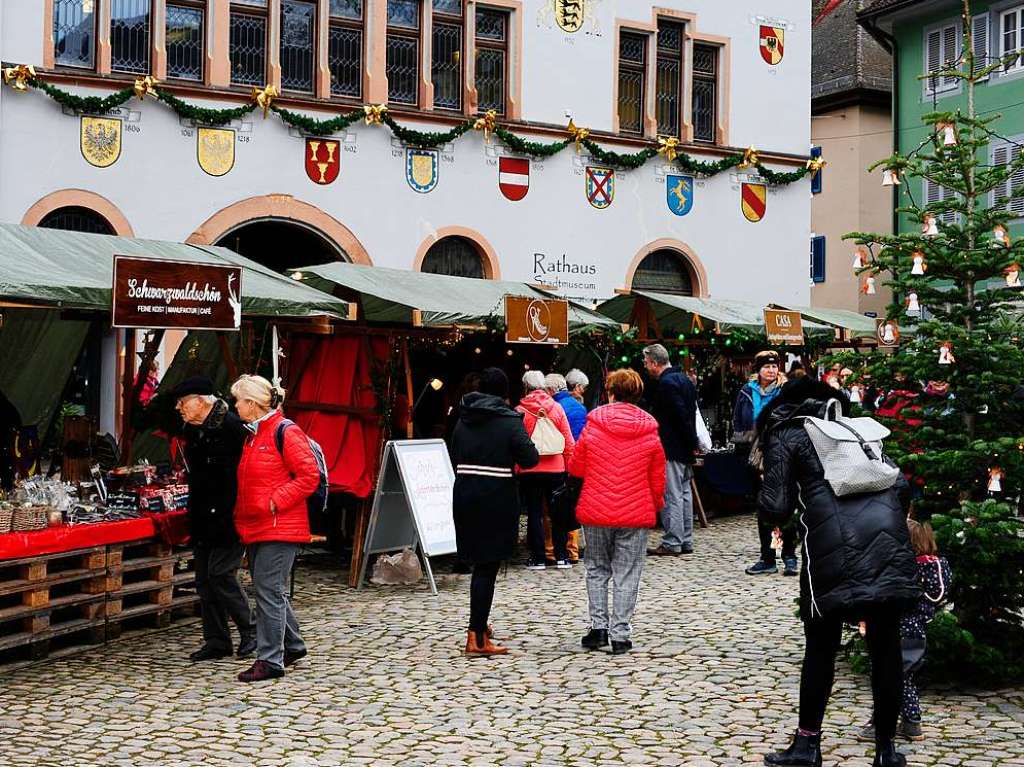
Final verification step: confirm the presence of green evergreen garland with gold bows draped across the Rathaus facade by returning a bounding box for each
[9,77,810,185]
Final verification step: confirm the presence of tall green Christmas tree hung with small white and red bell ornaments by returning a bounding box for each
[845,0,1024,680]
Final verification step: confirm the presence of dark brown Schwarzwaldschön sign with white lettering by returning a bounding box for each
[113,256,242,331]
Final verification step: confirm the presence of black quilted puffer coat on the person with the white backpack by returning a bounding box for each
[758,378,921,621]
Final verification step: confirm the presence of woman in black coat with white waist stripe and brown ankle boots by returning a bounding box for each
[451,368,541,655]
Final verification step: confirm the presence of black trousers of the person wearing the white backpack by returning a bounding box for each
[800,608,903,745]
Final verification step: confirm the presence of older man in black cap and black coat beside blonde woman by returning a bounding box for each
[173,377,256,662]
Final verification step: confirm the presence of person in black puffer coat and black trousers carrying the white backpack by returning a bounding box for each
[758,377,920,767]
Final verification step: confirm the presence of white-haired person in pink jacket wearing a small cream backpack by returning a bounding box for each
[516,371,575,570]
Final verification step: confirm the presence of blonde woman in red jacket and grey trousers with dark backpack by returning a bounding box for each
[231,376,319,682]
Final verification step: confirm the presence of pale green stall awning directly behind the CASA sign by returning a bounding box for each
[597,290,831,333]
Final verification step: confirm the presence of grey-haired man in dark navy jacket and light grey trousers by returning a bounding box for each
[643,344,697,556]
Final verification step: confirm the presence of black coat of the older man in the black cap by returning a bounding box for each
[184,399,250,546]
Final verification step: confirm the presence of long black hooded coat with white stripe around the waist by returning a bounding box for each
[452,391,541,563]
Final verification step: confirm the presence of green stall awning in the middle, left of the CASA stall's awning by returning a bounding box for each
[297,263,617,332]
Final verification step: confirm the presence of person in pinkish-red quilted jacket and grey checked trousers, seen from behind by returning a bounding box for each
[569,370,666,655]
